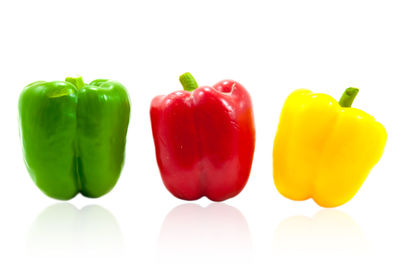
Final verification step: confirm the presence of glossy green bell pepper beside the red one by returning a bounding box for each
[19,77,130,200]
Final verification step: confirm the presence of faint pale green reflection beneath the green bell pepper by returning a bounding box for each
[27,203,124,257]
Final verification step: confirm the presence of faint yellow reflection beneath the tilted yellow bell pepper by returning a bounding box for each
[273,209,369,256]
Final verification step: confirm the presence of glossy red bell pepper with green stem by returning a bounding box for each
[150,73,255,201]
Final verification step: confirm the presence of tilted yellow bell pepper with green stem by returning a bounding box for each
[273,88,386,207]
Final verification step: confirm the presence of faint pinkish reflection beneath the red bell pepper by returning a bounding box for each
[158,203,252,265]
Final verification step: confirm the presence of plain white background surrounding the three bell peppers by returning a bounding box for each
[0,0,400,265]
